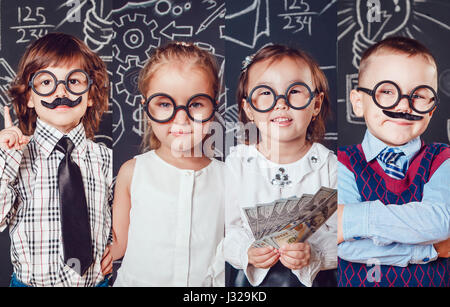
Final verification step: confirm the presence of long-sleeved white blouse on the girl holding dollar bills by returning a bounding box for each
[224,143,337,287]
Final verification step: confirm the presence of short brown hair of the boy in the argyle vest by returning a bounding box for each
[358,36,437,82]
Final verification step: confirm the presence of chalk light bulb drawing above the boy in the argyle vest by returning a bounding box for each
[352,0,411,69]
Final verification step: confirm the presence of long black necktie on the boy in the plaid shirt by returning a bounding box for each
[55,137,93,276]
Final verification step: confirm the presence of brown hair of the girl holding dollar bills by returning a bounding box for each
[236,44,330,144]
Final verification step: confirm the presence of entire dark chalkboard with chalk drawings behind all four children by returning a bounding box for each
[0,0,450,286]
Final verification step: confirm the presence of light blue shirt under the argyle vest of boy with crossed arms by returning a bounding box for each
[338,131,450,266]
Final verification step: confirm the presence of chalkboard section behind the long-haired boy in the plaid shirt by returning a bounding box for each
[0,0,113,287]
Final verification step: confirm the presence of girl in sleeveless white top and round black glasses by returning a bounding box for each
[102,42,225,286]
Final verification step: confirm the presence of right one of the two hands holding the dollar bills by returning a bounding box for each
[280,243,311,270]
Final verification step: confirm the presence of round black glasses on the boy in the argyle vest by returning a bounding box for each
[356,80,439,114]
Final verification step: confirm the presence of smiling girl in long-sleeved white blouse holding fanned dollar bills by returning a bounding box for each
[224,45,337,286]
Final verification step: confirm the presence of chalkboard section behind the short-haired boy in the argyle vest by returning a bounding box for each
[338,0,450,146]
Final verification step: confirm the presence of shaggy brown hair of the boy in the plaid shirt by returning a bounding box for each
[9,33,109,139]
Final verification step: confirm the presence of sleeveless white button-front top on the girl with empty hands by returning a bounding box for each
[114,151,225,287]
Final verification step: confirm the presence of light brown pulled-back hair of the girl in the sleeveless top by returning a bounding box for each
[138,42,220,151]
